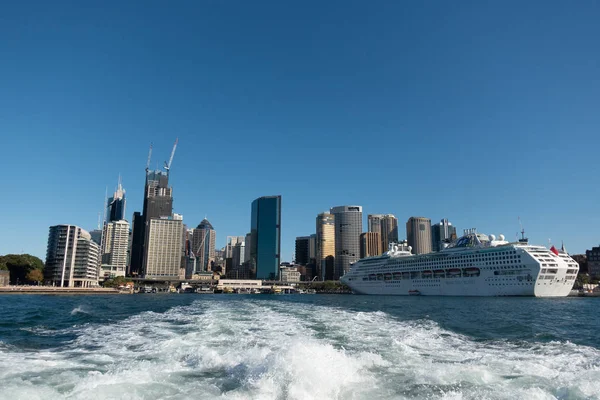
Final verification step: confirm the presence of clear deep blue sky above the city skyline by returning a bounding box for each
[0,0,600,260]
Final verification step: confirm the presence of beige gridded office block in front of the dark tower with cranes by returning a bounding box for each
[144,217,183,278]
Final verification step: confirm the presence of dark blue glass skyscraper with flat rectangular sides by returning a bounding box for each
[251,196,281,279]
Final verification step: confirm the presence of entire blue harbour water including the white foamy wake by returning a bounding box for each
[0,294,600,400]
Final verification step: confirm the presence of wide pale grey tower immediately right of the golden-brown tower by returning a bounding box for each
[331,206,362,280]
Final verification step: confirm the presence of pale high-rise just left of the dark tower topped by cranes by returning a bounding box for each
[102,220,129,278]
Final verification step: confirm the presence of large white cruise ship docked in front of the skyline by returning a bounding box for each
[340,230,579,297]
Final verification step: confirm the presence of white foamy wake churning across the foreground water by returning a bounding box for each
[0,298,600,399]
